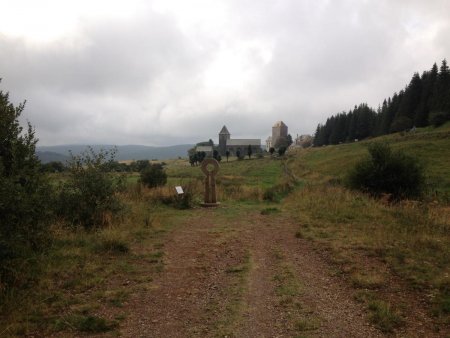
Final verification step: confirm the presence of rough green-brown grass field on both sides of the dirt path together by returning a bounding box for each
[0,124,450,336]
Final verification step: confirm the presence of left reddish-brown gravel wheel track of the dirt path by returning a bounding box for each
[121,210,250,337]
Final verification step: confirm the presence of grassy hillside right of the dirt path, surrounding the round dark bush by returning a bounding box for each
[284,124,450,331]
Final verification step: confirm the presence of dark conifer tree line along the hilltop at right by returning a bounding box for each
[314,59,450,146]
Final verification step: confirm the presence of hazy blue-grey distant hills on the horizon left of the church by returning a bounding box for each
[36,144,194,163]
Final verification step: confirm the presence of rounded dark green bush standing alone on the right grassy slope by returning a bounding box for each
[348,143,425,200]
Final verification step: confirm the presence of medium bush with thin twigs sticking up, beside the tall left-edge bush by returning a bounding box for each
[58,147,124,229]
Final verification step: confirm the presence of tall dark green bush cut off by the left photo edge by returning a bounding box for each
[0,83,52,292]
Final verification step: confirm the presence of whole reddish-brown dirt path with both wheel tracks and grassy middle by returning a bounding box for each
[116,207,381,337]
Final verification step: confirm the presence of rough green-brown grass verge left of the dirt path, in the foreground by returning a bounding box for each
[0,201,185,336]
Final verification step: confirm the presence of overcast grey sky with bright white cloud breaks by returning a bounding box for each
[0,0,450,146]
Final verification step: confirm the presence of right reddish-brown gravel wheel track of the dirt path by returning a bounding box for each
[236,215,382,337]
